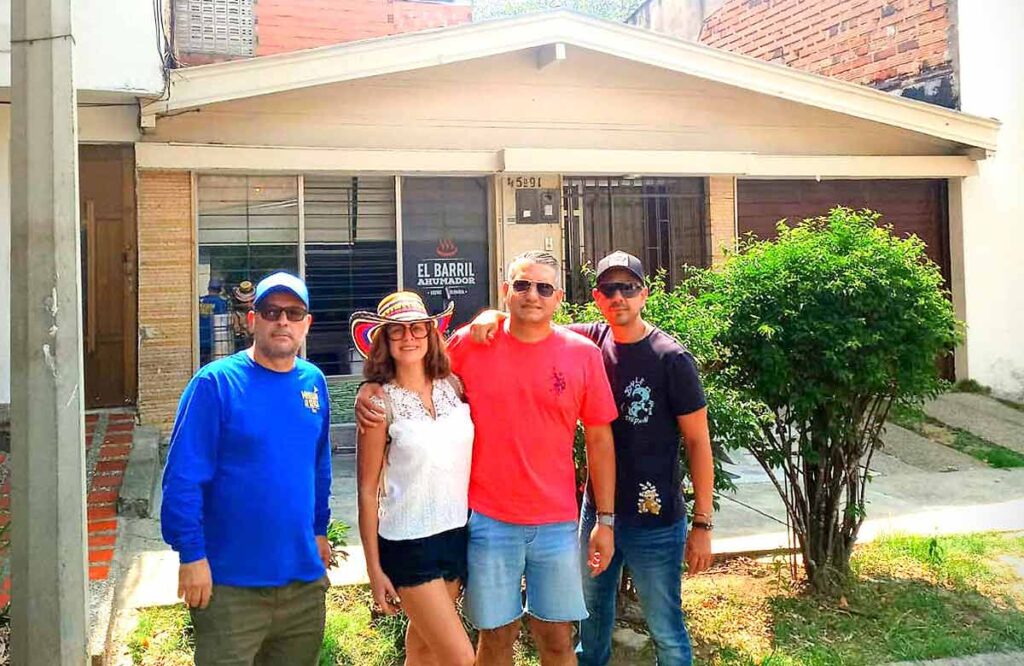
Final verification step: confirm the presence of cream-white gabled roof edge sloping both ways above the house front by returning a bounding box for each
[142,10,999,151]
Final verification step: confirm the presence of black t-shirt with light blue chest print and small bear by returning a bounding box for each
[569,324,707,527]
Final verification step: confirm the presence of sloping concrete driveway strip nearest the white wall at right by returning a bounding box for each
[925,393,1024,453]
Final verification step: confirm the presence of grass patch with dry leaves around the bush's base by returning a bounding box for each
[684,535,1024,666]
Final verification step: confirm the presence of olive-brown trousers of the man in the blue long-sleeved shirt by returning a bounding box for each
[190,576,330,666]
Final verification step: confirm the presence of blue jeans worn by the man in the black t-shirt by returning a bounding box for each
[577,498,693,666]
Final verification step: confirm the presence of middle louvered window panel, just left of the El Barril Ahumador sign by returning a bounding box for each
[303,176,398,375]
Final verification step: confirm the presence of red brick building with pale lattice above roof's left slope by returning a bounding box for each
[170,0,472,65]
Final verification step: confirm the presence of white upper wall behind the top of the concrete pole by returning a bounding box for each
[0,0,164,94]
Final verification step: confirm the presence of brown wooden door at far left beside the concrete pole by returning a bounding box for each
[79,145,137,408]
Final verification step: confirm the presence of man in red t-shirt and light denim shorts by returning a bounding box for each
[356,251,617,665]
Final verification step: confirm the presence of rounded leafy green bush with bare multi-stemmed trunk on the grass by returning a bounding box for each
[690,207,961,592]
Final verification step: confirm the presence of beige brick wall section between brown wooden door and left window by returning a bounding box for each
[138,171,196,430]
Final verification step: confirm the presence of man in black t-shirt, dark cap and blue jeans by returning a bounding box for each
[473,252,714,666]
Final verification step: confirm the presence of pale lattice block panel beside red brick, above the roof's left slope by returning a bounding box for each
[174,0,256,55]
